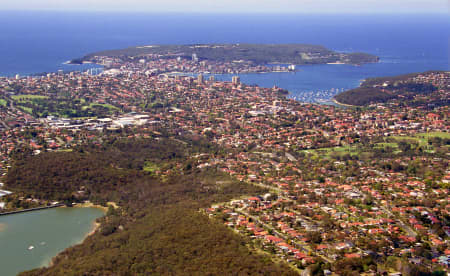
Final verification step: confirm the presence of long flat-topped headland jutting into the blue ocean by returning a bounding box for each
[70,44,379,73]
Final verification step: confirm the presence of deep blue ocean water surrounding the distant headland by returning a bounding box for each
[0,11,450,100]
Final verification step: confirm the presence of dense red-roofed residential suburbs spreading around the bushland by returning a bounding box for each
[0,59,450,275]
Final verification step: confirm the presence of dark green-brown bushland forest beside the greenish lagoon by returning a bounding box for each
[6,138,294,275]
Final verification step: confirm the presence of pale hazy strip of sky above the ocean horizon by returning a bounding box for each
[0,0,450,13]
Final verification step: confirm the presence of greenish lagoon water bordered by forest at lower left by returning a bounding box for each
[0,208,104,276]
